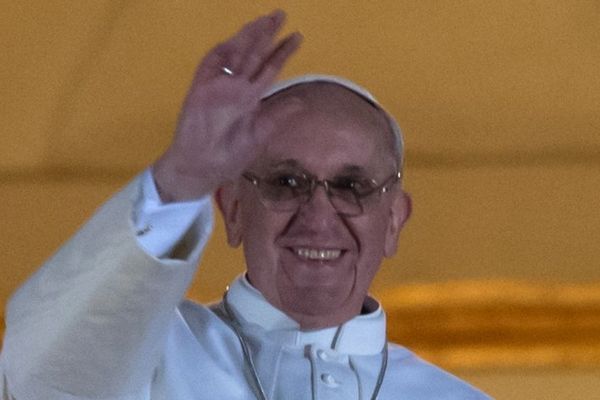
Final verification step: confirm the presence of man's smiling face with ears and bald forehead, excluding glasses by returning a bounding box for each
[220,83,410,329]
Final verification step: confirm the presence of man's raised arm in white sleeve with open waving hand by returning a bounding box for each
[0,11,301,400]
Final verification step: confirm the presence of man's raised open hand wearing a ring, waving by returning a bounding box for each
[152,11,302,202]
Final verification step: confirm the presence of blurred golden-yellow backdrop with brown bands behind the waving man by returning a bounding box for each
[0,0,600,399]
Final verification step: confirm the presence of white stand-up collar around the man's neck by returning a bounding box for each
[227,275,386,355]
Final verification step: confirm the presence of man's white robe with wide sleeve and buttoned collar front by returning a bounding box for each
[0,180,488,400]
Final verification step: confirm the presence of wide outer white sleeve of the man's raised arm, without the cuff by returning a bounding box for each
[0,177,213,400]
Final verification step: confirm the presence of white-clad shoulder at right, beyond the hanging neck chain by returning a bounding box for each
[386,343,490,400]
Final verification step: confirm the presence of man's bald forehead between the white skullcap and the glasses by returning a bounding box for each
[258,82,395,173]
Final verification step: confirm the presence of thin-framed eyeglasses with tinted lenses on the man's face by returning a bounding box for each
[242,171,401,216]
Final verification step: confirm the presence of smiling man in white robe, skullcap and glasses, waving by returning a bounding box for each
[0,12,487,400]
